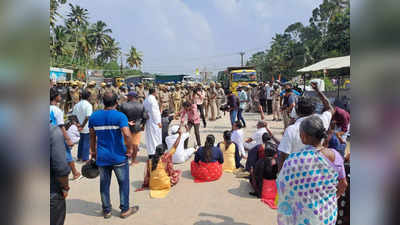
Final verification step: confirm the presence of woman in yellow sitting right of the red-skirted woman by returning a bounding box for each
[217,130,240,173]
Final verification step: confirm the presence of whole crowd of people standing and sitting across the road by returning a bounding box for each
[50,78,350,225]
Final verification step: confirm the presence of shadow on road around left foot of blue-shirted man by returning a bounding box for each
[67,199,120,217]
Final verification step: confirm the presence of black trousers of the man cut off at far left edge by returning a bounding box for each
[50,193,66,225]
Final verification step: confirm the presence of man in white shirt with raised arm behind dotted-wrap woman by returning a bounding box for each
[278,83,335,169]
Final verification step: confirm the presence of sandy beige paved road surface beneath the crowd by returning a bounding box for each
[65,113,283,225]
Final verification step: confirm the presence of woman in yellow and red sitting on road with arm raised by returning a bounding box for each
[143,129,182,198]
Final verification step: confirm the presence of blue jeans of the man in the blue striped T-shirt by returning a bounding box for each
[99,162,129,213]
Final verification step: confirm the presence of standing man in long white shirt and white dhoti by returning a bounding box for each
[143,87,162,159]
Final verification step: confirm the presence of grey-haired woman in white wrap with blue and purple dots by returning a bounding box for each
[277,116,347,225]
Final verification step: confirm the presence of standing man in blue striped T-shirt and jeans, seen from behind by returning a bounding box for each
[89,92,139,219]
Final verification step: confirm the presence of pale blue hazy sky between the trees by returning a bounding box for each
[60,0,322,74]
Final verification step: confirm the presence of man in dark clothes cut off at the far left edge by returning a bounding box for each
[49,125,71,225]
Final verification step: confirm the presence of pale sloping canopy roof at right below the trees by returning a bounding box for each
[297,56,350,72]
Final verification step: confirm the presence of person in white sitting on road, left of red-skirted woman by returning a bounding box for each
[165,125,195,163]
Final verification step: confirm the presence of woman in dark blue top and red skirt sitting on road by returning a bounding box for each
[190,135,224,183]
